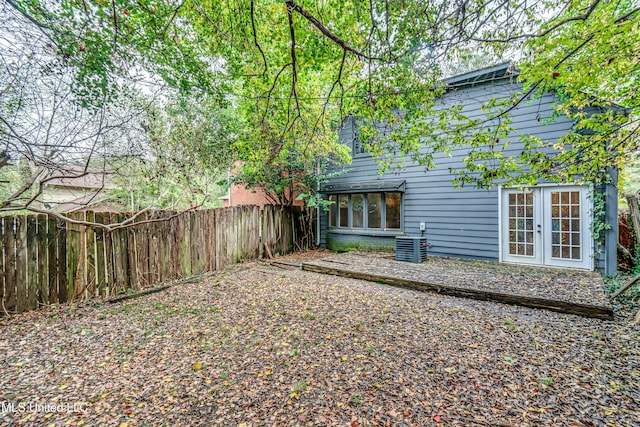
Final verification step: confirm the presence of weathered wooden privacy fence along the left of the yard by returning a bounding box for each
[0,206,302,315]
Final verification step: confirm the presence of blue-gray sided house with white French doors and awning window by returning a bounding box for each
[319,64,618,274]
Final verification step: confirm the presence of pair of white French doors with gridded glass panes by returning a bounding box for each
[500,185,593,269]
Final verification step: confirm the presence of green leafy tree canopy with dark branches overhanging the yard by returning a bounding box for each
[2,0,640,211]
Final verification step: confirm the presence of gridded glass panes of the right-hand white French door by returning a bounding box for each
[551,191,582,260]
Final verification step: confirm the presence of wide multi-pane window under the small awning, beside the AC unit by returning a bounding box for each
[328,192,402,231]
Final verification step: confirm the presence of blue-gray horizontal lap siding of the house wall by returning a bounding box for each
[321,78,617,273]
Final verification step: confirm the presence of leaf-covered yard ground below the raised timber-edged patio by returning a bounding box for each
[0,253,640,426]
